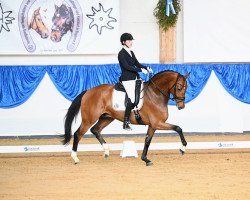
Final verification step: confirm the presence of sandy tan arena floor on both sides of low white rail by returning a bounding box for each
[0,134,250,200]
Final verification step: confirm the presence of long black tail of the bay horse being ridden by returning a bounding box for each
[62,91,86,145]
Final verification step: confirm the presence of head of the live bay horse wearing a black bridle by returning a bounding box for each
[169,72,190,110]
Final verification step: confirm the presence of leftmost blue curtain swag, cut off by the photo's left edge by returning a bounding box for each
[0,66,46,108]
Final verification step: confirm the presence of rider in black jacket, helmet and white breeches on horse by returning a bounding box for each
[118,33,153,130]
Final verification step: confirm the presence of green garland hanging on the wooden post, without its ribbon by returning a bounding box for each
[154,0,181,31]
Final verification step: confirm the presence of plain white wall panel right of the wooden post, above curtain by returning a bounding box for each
[183,0,250,62]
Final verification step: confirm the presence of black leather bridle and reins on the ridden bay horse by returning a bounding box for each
[149,73,185,103]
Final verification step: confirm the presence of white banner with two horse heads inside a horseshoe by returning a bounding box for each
[0,0,120,55]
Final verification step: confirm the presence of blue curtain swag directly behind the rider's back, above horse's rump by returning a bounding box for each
[47,64,121,101]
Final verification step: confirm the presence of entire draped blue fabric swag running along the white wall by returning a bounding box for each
[0,64,250,108]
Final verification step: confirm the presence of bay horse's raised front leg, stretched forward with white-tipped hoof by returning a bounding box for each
[154,122,187,155]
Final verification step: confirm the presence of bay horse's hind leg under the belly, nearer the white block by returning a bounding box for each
[90,114,114,158]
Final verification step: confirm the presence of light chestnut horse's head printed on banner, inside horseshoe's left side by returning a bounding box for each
[29,7,49,38]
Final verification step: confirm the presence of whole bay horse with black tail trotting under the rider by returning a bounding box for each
[62,70,190,166]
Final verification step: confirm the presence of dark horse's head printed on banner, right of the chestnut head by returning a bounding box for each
[50,4,74,42]
